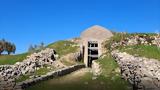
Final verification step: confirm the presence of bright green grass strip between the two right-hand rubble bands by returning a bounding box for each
[119,45,160,60]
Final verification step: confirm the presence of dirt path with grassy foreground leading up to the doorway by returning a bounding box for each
[26,68,91,90]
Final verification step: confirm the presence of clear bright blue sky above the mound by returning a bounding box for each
[0,0,160,53]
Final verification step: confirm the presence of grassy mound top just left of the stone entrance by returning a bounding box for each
[47,41,78,56]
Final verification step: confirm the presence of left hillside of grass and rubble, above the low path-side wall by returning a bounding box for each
[0,41,81,89]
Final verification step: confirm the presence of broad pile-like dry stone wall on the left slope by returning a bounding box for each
[0,48,57,90]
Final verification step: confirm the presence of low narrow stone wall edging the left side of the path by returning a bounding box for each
[15,64,85,90]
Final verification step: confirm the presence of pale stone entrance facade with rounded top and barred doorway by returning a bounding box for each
[81,25,113,67]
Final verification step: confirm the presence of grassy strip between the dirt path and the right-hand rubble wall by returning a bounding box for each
[97,54,131,90]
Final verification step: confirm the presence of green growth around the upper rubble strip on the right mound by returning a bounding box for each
[105,33,160,60]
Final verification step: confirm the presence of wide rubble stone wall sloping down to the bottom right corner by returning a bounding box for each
[112,50,160,90]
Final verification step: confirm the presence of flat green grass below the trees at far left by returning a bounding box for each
[0,53,29,65]
